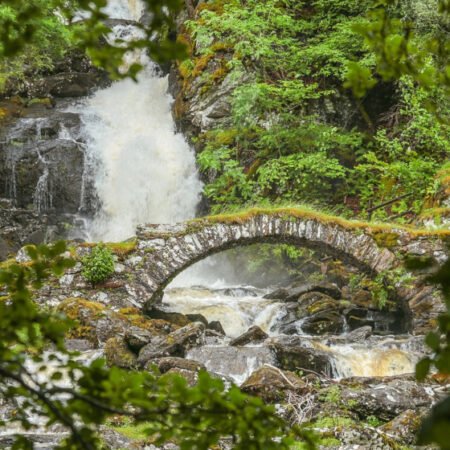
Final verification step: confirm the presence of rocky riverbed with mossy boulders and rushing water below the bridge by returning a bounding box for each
[0,243,450,449]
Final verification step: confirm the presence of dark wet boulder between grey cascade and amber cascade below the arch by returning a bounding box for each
[269,340,334,376]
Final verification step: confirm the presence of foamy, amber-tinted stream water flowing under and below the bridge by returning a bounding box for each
[163,280,421,384]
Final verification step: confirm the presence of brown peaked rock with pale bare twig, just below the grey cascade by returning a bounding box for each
[240,366,307,402]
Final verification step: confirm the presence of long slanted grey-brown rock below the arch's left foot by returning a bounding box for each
[138,322,205,366]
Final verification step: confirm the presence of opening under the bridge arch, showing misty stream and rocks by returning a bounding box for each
[150,243,410,337]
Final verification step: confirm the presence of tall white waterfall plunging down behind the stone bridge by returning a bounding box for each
[79,0,202,241]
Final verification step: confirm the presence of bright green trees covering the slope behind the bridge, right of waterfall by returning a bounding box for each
[187,0,448,221]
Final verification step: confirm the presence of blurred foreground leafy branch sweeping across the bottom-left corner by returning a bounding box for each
[0,242,314,450]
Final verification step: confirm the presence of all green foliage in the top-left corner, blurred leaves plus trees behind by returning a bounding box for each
[0,0,185,79]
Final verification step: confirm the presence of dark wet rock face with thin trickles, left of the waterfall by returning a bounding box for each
[0,102,89,213]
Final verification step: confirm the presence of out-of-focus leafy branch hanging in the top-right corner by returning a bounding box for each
[347,0,450,108]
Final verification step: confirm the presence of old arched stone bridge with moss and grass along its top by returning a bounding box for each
[126,209,450,332]
